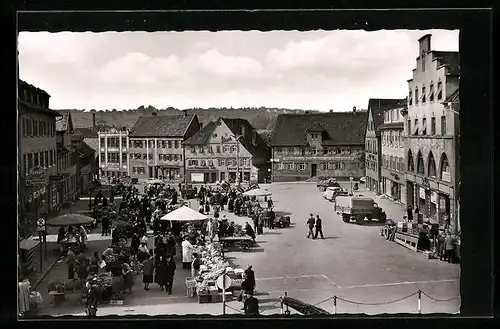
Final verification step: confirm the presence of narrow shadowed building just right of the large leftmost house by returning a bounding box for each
[54,110,78,206]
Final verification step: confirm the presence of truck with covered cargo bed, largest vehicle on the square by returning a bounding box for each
[335,196,387,224]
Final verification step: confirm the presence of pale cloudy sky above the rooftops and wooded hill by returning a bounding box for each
[18,30,459,111]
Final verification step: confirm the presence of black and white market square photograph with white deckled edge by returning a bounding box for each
[17,22,461,319]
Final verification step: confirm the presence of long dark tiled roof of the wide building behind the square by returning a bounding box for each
[271,110,367,146]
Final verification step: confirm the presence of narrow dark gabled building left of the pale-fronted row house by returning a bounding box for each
[365,98,405,194]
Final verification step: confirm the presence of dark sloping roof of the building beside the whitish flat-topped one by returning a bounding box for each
[129,115,196,137]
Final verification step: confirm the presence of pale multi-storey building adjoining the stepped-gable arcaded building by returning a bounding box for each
[380,103,406,205]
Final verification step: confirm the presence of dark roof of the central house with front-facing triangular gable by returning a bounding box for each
[184,118,270,157]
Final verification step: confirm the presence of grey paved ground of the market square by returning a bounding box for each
[33,182,460,315]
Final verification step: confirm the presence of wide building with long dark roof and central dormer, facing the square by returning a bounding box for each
[271,108,367,182]
